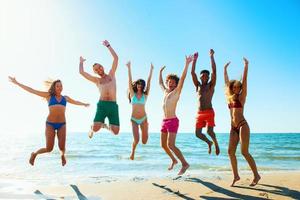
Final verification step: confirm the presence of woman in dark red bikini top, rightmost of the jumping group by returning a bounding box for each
[224,58,260,186]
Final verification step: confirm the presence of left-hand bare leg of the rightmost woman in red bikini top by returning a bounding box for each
[228,131,240,186]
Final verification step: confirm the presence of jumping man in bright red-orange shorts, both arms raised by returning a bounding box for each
[191,49,220,155]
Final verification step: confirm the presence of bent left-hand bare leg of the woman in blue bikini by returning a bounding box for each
[29,125,55,166]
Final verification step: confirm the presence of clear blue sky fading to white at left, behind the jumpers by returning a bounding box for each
[0,0,300,134]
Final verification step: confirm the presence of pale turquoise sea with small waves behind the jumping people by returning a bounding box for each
[0,132,300,184]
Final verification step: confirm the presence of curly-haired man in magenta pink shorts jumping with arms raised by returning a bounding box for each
[159,56,193,175]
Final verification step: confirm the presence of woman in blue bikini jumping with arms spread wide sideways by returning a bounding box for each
[9,77,89,166]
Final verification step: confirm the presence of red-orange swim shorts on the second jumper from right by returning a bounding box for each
[196,109,215,128]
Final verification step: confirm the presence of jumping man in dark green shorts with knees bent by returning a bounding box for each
[79,40,120,138]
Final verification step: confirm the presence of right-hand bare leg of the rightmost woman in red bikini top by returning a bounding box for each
[240,123,260,186]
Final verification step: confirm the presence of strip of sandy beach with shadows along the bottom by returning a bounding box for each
[0,171,300,200]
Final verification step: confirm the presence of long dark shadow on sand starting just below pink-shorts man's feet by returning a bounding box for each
[186,178,267,200]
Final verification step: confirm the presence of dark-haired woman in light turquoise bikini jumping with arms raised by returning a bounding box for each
[126,62,153,160]
